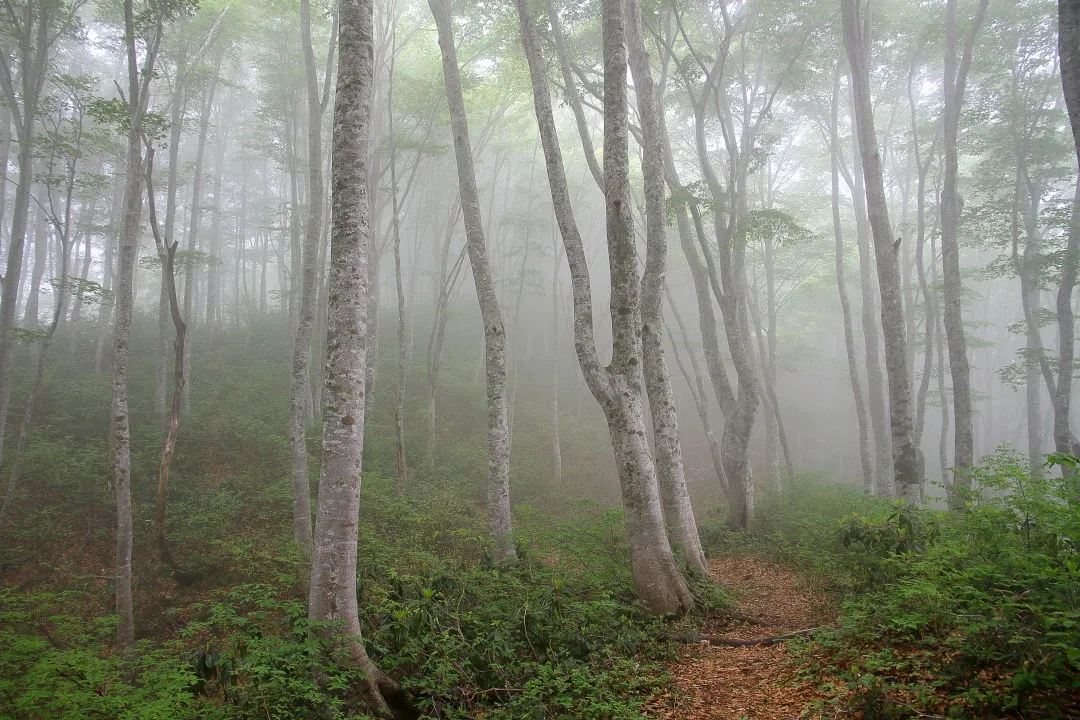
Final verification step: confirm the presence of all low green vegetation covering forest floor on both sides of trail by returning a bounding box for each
[0,323,1080,720]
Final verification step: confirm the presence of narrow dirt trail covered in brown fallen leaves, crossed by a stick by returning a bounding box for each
[649,557,833,720]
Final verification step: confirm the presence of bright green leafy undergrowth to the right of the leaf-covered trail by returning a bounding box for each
[714,451,1080,720]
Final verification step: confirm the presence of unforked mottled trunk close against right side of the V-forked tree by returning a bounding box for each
[626,0,708,576]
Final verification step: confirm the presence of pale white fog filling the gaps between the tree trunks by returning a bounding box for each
[0,1,1077,518]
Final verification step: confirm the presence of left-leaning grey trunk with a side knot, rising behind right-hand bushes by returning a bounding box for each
[841,0,922,504]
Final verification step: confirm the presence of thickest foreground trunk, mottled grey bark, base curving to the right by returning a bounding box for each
[308,0,400,718]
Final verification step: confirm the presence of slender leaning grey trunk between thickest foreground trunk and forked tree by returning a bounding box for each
[428,0,517,562]
